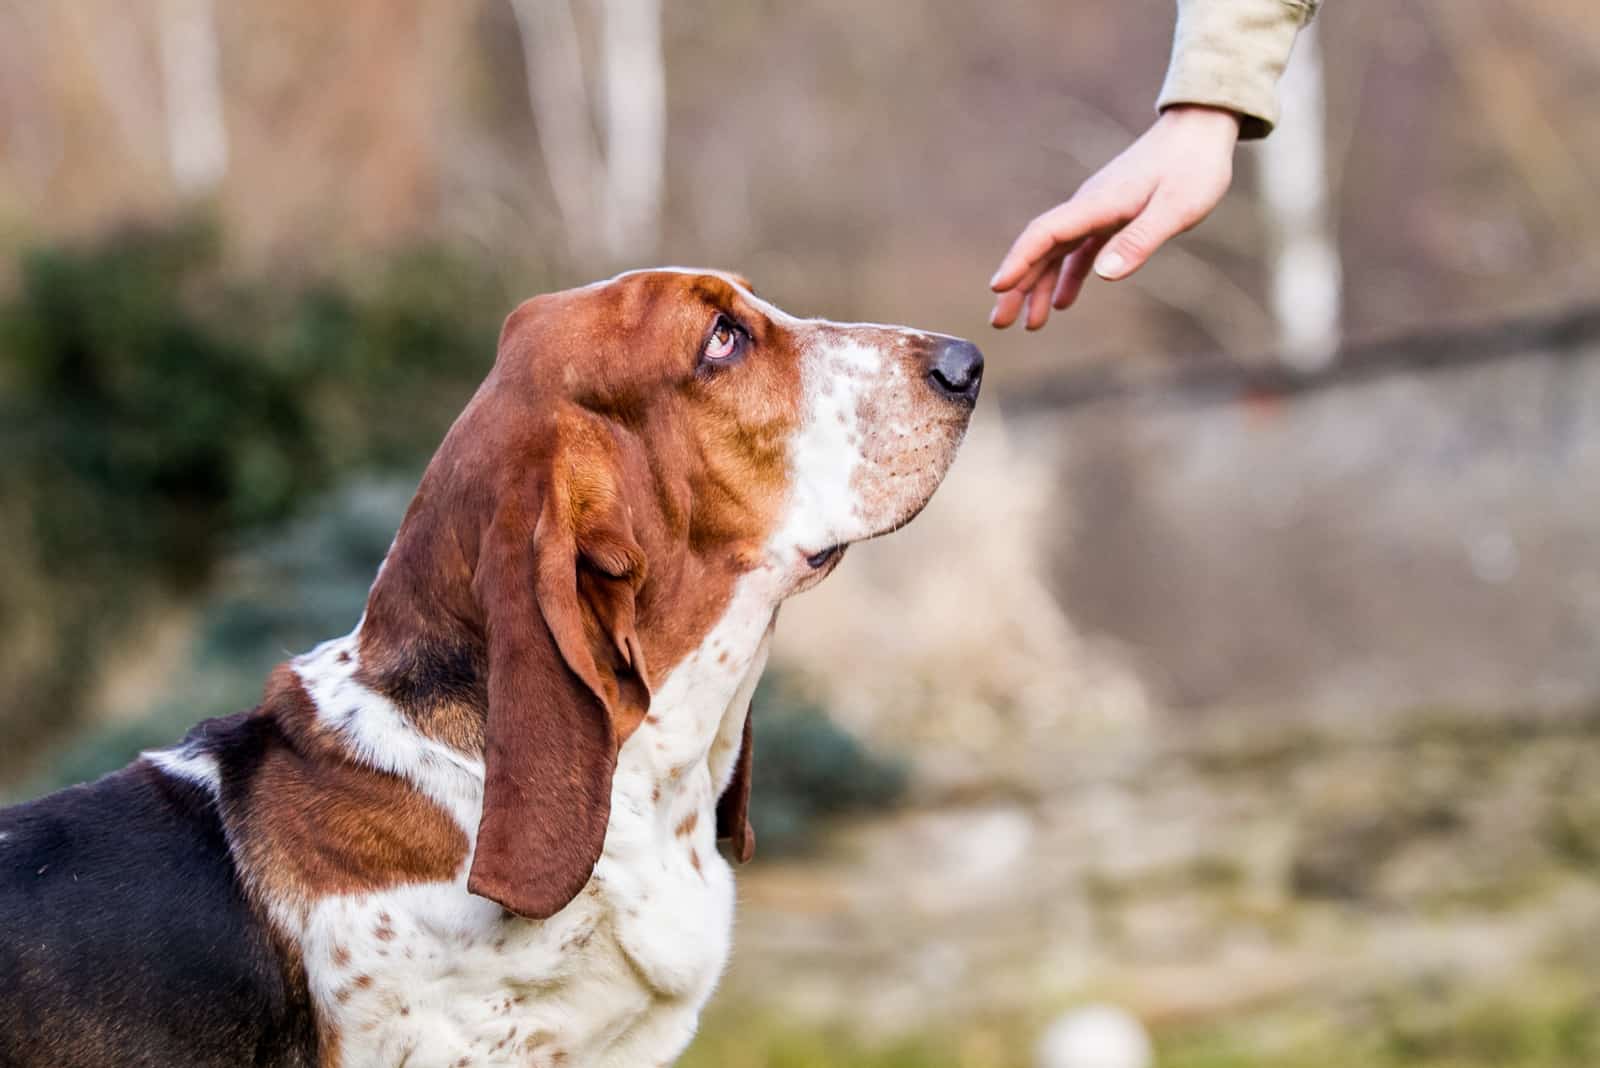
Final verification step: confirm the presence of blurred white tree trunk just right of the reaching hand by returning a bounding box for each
[1254,24,1342,371]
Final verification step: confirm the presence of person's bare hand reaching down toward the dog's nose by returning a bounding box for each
[989,104,1238,329]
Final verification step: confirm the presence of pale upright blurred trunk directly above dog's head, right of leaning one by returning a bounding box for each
[602,0,667,262]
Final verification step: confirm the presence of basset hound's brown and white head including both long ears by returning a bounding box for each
[362,270,982,916]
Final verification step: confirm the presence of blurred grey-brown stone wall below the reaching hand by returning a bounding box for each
[1036,313,1600,716]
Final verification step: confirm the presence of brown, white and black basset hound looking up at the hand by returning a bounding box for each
[0,270,982,1068]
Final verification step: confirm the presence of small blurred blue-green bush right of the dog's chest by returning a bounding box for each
[750,670,907,859]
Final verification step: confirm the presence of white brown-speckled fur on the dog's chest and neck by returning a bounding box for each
[285,576,774,1068]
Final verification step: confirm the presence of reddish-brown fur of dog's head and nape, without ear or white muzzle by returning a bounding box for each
[362,272,805,729]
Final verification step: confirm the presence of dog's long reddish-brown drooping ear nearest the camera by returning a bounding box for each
[467,441,650,919]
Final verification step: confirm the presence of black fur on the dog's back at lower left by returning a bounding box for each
[0,716,315,1068]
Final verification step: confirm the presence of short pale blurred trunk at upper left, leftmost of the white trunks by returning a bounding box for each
[160,0,227,197]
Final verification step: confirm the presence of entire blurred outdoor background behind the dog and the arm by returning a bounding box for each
[0,0,1600,1068]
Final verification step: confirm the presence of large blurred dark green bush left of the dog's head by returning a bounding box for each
[0,222,507,761]
